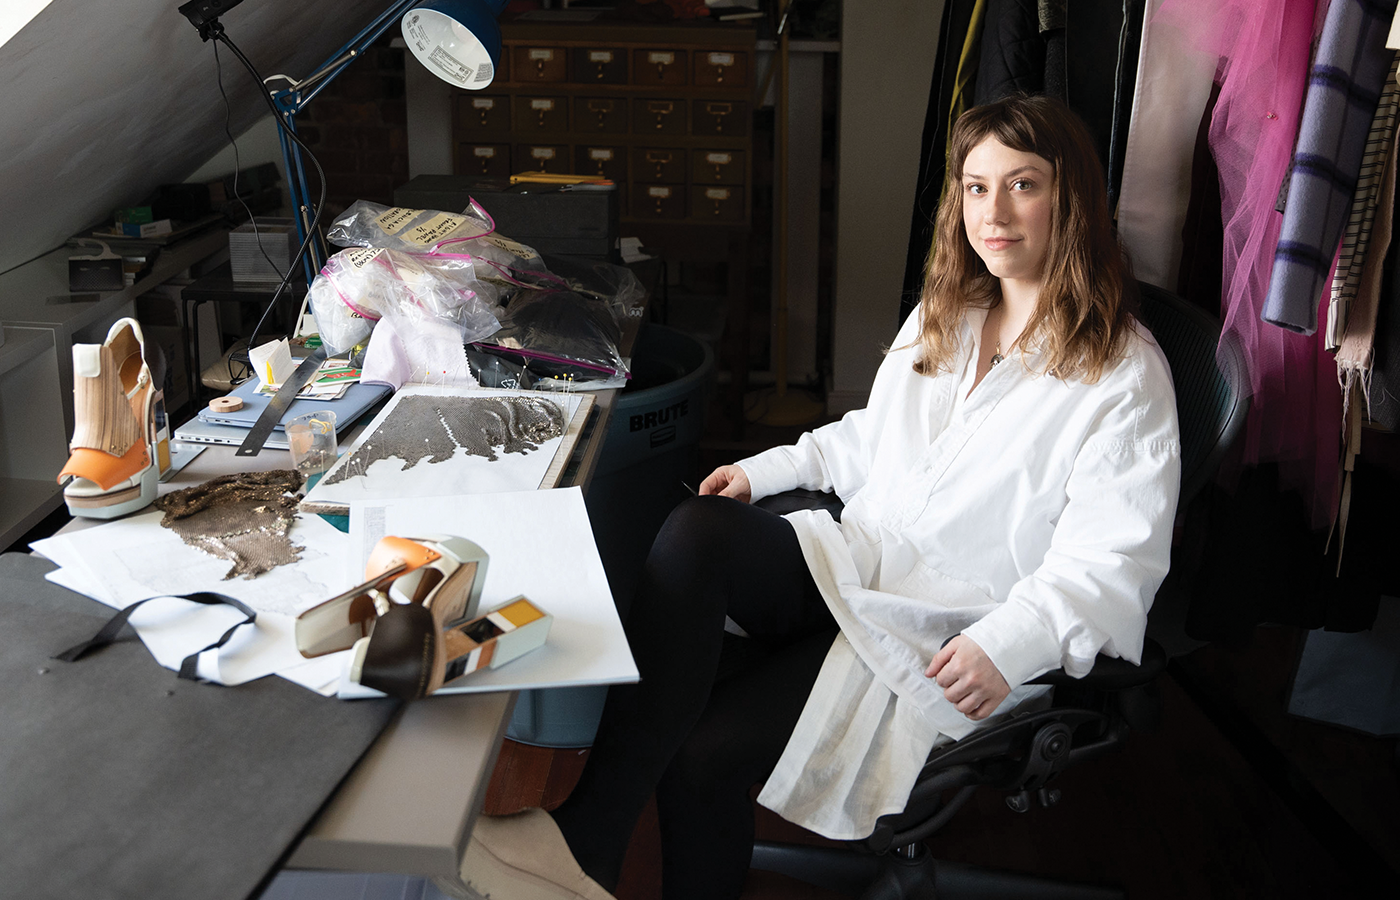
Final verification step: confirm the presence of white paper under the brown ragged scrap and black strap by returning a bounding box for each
[32,512,358,684]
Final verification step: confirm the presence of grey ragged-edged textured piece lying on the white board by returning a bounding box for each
[325,395,564,484]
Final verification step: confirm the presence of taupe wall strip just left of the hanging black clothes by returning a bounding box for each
[827,0,944,414]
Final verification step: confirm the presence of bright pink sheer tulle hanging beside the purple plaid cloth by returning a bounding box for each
[1154,0,1341,528]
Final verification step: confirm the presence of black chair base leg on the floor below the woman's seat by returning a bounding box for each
[750,841,1127,900]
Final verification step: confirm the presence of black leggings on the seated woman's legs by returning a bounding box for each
[554,497,836,900]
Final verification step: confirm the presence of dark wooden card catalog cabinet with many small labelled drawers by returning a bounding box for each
[452,22,756,228]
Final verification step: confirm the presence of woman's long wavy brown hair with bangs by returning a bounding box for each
[914,95,1137,384]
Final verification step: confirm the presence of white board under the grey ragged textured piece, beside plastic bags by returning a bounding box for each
[305,385,582,515]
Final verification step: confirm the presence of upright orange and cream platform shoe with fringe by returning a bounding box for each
[59,319,169,519]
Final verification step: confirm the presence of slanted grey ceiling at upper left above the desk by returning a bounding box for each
[0,0,389,275]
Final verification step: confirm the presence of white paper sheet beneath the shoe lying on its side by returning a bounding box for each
[340,487,638,698]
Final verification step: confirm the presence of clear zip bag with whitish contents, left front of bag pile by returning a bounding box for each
[309,249,500,353]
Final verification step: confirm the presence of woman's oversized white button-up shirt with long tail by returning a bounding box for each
[739,309,1180,840]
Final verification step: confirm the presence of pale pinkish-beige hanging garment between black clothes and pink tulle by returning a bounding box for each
[1117,0,1219,288]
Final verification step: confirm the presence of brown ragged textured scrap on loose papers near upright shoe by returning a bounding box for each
[155,469,305,581]
